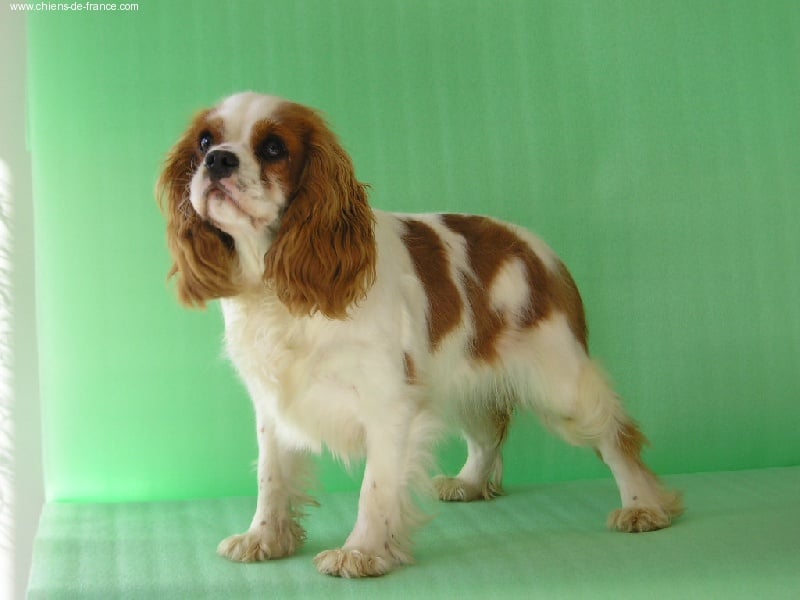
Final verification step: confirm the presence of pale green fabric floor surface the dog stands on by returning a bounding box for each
[29,467,800,600]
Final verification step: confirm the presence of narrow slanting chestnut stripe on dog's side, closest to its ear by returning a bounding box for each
[403,219,463,350]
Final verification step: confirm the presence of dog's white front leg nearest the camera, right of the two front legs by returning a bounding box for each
[314,418,423,578]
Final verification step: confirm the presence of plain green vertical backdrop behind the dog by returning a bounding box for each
[28,0,800,500]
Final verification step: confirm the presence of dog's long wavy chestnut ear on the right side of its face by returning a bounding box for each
[264,113,377,319]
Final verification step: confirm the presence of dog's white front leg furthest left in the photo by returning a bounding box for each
[217,415,313,562]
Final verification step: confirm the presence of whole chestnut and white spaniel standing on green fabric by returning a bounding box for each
[158,92,682,577]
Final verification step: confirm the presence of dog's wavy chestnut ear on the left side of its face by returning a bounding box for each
[156,111,240,308]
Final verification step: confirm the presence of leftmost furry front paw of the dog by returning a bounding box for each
[217,522,305,562]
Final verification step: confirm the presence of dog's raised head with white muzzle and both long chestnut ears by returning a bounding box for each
[158,92,376,318]
